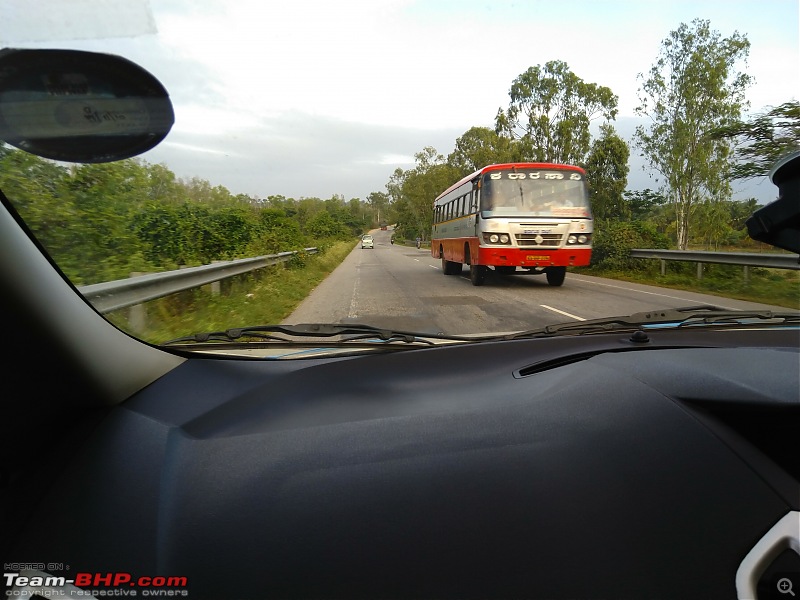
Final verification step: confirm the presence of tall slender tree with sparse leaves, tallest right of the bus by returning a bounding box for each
[634,19,752,250]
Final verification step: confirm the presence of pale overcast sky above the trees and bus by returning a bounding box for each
[0,0,800,201]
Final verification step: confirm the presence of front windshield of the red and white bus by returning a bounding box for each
[481,171,591,218]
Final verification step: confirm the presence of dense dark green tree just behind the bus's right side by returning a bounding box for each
[586,123,630,219]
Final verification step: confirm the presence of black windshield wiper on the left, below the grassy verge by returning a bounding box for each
[162,323,482,346]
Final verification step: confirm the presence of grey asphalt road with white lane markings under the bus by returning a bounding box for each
[285,230,781,334]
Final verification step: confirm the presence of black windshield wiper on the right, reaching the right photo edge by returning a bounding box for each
[501,304,800,340]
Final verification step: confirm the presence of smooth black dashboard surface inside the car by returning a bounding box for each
[12,334,800,599]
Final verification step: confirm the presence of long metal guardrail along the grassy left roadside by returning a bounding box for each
[78,248,318,314]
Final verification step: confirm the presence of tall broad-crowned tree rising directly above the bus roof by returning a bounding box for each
[495,60,617,164]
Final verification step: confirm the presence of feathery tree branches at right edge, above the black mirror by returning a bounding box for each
[714,100,800,179]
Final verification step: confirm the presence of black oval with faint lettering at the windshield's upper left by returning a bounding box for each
[0,48,175,163]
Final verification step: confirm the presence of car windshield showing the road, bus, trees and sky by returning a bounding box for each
[0,0,800,344]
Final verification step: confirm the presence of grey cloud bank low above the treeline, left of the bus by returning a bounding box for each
[143,112,463,199]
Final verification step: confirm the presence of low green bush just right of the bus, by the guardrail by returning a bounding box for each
[591,220,669,271]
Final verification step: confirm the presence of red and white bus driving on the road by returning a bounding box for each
[431,163,593,285]
